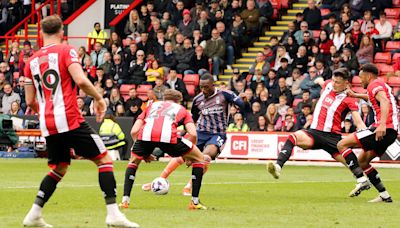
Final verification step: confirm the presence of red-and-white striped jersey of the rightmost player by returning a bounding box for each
[367,79,399,131]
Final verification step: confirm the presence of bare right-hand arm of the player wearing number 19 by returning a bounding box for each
[68,63,107,122]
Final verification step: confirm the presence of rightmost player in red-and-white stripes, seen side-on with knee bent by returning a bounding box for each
[338,64,399,203]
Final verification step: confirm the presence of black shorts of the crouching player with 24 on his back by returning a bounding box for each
[131,138,194,160]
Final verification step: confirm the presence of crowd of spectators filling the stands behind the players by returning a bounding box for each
[0,0,400,132]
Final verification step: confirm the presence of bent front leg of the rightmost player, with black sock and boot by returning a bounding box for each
[338,130,375,197]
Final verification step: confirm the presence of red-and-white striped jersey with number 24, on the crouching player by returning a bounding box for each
[138,101,193,144]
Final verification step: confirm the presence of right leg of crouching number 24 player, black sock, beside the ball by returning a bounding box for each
[183,146,207,210]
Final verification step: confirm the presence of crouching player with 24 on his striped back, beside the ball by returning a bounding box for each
[121,89,207,210]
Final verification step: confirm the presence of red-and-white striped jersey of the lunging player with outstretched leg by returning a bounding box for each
[310,82,358,134]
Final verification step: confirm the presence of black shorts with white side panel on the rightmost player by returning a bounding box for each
[354,127,397,157]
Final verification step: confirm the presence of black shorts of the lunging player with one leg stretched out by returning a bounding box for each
[303,129,342,157]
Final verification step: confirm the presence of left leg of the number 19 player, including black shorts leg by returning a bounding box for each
[23,135,70,227]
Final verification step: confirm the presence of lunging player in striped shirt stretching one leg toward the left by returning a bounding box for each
[267,68,365,183]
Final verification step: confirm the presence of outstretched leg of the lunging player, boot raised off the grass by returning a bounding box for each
[267,131,314,179]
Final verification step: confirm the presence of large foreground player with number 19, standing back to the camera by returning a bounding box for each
[23,15,139,227]
